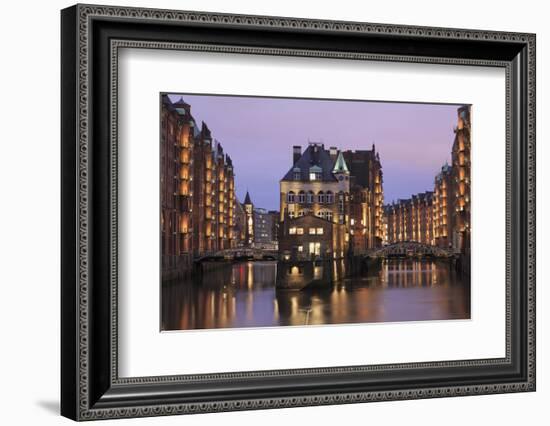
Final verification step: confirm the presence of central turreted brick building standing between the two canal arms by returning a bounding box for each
[279,143,383,258]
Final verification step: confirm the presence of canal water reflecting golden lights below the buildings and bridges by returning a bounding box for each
[161,259,470,330]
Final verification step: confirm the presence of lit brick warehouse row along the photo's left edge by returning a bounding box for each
[160,95,238,278]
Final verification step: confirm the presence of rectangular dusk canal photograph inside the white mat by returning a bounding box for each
[161,93,475,331]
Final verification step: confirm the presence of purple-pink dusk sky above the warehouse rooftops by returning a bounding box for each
[166,94,468,210]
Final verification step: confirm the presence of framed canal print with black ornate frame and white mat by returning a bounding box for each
[61,5,535,420]
